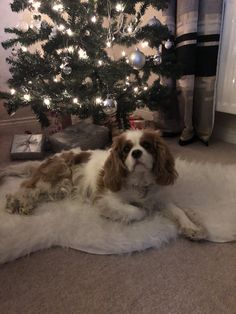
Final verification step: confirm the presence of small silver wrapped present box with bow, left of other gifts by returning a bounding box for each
[10,134,45,159]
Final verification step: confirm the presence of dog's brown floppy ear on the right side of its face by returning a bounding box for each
[153,134,178,185]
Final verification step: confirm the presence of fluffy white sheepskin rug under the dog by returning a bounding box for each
[0,159,236,263]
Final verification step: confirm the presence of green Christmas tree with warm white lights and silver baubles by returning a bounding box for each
[0,0,179,126]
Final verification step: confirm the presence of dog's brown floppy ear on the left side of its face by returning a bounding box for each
[103,136,127,192]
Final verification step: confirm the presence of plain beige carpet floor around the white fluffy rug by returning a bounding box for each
[0,113,236,314]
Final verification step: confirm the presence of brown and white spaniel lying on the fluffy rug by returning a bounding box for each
[2,130,206,240]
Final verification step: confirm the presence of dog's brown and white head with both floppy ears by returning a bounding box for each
[104,130,177,192]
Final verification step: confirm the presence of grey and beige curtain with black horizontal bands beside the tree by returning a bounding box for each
[164,0,223,145]
